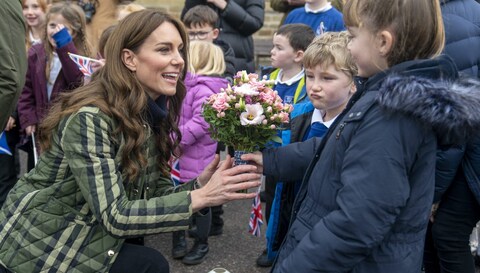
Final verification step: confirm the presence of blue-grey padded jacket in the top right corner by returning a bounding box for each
[439,0,480,78]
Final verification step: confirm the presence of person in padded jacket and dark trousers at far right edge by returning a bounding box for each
[424,0,480,273]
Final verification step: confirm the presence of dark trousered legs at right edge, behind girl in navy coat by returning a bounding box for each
[424,131,480,273]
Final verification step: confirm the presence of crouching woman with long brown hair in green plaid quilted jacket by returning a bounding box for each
[0,10,260,273]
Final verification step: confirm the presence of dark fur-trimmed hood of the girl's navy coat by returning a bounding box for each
[377,75,480,145]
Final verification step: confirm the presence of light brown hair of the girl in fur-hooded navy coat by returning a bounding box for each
[343,0,445,66]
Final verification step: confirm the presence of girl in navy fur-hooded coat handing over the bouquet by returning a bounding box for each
[242,0,480,273]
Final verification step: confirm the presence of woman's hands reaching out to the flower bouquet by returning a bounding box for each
[191,155,261,211]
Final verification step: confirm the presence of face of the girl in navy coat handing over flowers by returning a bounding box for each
[348,27,388,78]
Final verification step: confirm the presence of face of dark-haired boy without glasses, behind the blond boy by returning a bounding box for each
[270,34,302,69]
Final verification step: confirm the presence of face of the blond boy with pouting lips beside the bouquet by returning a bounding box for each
[305,64,355,117]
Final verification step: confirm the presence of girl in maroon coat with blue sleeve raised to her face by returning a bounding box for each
[18,3,91,169]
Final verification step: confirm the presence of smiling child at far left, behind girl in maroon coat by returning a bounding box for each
[23,0,48,50]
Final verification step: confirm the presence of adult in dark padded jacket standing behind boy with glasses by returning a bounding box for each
[181,0,265,73]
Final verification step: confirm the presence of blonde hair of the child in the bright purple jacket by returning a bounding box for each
[189,40,226,76]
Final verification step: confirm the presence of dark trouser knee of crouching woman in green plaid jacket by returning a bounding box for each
[109,244,170,273]
